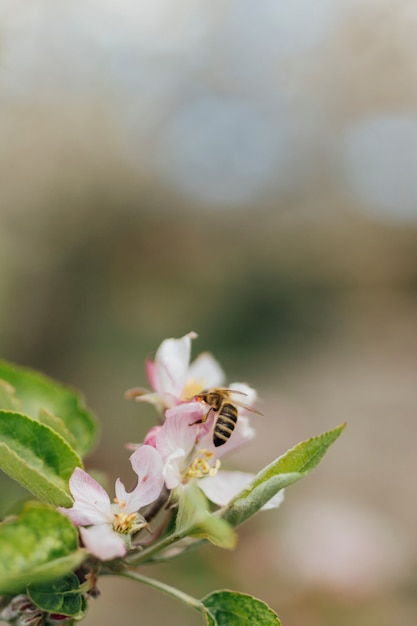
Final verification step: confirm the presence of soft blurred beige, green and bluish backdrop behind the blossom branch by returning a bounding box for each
[0,0,417,626]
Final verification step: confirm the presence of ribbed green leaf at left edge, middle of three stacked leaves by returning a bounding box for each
[0,410,82,506]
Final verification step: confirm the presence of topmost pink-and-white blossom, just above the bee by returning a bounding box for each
[126,332,224,411]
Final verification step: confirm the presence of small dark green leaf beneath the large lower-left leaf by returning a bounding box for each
[27,572,85,617]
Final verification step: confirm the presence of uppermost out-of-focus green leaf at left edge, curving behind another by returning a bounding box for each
[0,361,97,456]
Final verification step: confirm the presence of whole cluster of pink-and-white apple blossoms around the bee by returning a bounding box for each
[60,333,282,561]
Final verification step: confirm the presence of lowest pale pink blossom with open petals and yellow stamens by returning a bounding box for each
[59,445,164,561]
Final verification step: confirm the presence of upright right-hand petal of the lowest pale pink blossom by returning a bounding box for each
[126,445,164,513]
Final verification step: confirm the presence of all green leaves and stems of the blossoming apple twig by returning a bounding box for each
[0,352,345,626]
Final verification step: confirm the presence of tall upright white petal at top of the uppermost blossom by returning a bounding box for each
[153,332,197,397]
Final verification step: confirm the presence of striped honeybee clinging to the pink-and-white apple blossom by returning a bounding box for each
[194,387,262,448]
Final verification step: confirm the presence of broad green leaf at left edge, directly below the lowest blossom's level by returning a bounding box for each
[0,502,86,594]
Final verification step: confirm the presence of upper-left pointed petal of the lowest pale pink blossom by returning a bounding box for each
[59,467,113,526]
